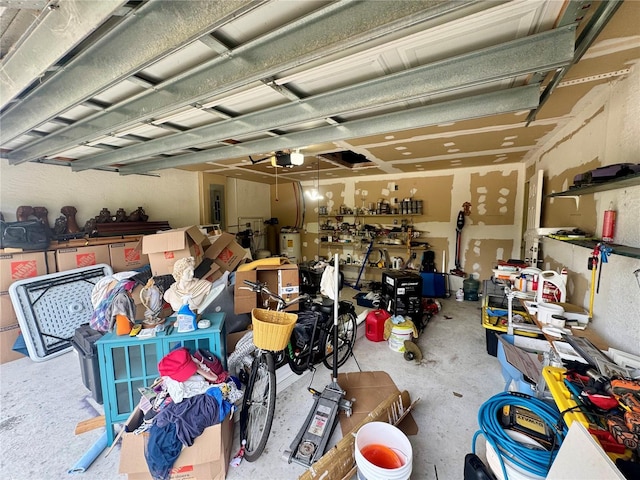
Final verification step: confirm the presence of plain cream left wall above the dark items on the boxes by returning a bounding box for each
[0,160,199,227]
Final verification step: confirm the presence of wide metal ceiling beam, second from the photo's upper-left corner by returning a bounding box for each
[2,0,262,141]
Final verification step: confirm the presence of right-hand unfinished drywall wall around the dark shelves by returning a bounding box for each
[528,61,640,354]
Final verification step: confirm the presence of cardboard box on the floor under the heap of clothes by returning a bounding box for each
[119,412,234,480]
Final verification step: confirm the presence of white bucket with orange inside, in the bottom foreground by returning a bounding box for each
[355,422,413,480]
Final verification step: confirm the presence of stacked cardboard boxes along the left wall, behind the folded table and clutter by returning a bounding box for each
[0,225,299,363]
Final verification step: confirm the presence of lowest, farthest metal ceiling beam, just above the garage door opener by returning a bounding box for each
[120,84,540,175]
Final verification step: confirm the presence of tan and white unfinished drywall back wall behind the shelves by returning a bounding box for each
[302,164,524,287]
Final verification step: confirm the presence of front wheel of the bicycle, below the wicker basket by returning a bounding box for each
[240,352,276,462]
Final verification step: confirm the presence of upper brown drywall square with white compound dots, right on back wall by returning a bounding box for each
[470,170,518,225]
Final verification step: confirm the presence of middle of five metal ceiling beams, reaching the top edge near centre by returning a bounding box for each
[8,0,496,164]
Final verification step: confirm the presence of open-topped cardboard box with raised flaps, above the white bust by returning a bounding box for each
[142,225,209,276]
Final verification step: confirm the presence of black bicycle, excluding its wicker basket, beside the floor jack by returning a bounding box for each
[240,280,357,462]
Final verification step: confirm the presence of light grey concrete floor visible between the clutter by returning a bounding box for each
[0,288,504,480]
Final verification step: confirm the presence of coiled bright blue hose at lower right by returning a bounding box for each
[471,392,567,480]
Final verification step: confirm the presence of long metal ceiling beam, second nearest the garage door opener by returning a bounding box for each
[71,25,575,171]
